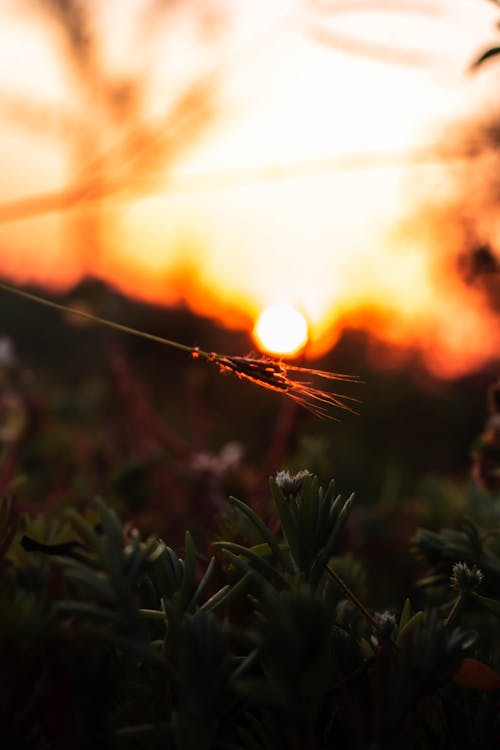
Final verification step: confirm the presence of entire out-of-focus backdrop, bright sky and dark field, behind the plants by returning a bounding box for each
[0,0,500,600]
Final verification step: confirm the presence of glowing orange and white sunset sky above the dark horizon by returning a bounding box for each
[0,0,500,377]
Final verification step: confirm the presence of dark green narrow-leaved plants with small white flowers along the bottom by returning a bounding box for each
[0,378,500,750]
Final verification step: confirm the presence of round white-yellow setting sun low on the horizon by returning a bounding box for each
[254,305,308,355]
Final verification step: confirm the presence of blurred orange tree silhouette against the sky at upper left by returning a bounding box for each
[0,0,223,273]
